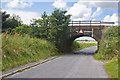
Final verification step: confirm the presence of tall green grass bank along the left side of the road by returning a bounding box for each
[2,33,57,71]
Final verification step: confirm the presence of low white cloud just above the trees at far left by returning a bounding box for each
[3,9,41,24]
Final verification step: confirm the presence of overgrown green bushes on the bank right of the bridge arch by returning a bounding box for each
[96,26,120,60]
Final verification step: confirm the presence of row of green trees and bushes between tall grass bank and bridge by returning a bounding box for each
[6,9,70,52]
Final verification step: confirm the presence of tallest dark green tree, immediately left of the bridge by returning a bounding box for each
[50,9,70,51]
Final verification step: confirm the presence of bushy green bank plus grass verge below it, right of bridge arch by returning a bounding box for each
[94,26,120,78]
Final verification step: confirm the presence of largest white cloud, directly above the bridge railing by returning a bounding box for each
[66,1,118,20]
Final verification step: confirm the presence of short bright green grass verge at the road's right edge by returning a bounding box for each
[94,53,118,78]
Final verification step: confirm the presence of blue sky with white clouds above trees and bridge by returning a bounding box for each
[1,0,118,40]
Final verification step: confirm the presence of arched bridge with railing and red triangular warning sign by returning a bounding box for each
[69,21,114,48]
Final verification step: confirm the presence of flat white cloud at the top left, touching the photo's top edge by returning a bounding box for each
[5,0,33,8]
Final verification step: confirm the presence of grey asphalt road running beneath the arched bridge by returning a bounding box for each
[9,46,109,78]
